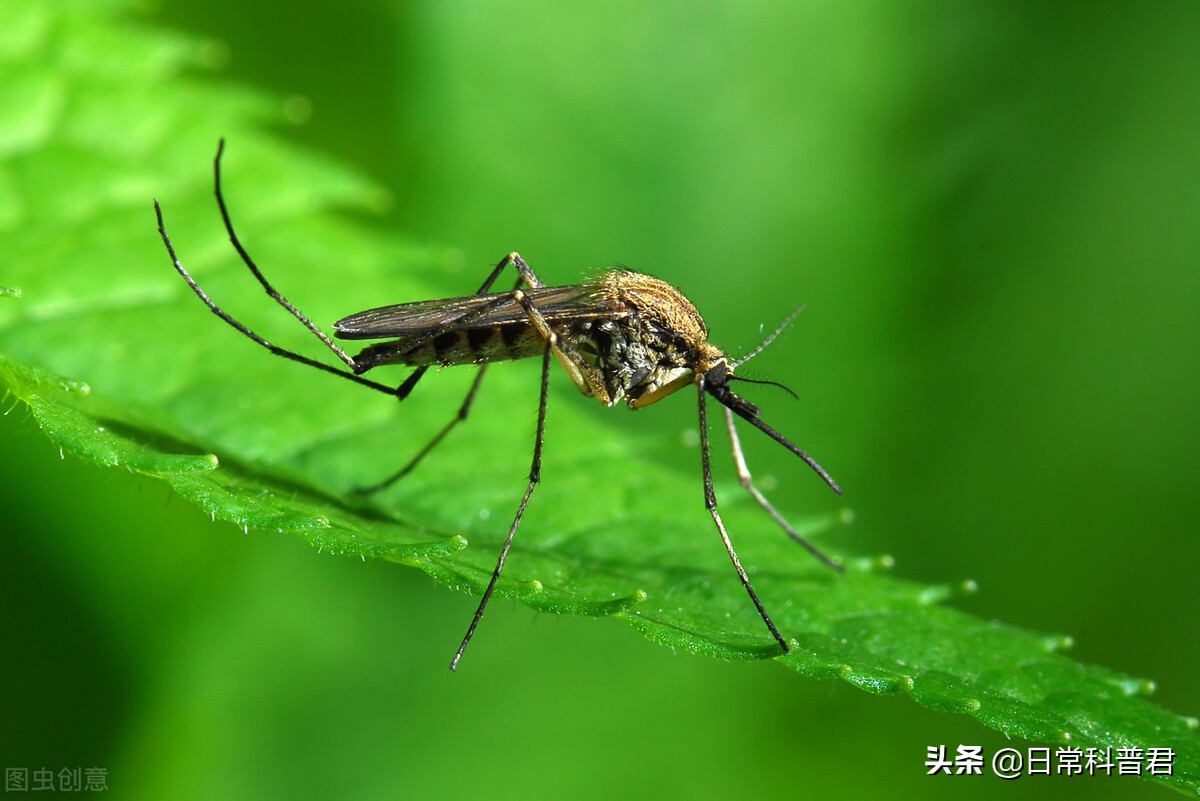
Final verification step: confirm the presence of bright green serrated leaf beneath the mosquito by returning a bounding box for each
[0,4,1200,789]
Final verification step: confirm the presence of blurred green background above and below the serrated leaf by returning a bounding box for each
[0,0,1200,799]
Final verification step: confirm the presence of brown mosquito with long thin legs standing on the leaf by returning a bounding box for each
[154,139,842,670]
